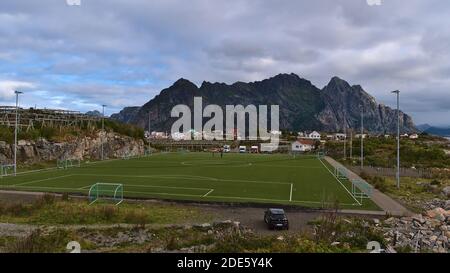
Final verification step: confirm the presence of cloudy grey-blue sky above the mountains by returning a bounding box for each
[0,0,450,125]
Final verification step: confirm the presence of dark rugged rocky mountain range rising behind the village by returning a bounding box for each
[111,74,417,133]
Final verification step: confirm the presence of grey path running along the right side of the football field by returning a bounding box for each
[325,156,412,216]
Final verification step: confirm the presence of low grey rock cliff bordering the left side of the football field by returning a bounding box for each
[0,133,144,164]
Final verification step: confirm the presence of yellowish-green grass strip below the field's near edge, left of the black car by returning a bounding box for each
[0,195,211,227]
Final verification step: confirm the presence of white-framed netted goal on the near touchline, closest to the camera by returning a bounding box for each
[89,183,123,205]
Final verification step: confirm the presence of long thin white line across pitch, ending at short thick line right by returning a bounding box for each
[73,173,291,185]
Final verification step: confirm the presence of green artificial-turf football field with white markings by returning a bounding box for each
[0,152,378,210]
